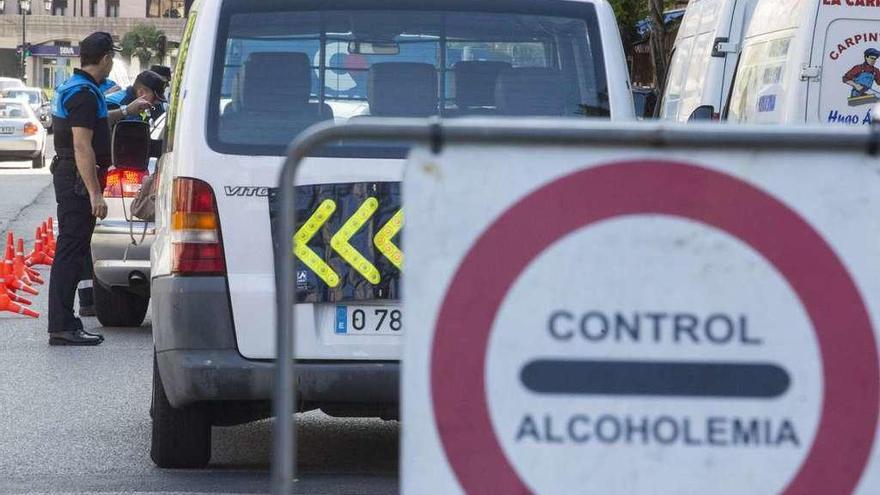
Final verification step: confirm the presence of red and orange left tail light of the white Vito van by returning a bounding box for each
[171,177,226,275]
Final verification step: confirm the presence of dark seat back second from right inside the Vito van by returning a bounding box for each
[452,61,511,115]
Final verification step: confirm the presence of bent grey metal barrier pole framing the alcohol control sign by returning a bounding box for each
[272,118,878,495]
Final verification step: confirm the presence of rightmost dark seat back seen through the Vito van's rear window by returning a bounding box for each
[495,67,566,116]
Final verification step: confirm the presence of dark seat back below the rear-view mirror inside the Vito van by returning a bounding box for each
[368,62,438,117]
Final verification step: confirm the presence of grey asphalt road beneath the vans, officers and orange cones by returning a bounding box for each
[0,142,400,494]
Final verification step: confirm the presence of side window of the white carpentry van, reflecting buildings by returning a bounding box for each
[728,35,793,124]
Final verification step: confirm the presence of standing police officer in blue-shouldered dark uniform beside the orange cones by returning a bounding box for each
[49,32,150,345]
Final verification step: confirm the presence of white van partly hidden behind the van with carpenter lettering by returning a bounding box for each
[659,0,757,122]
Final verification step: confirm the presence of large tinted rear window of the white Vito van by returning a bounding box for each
[208,0,610,157]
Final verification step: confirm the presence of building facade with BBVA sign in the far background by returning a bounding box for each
[0,0,186,89]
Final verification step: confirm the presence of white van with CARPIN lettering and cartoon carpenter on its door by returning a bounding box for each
[727,0,880,125]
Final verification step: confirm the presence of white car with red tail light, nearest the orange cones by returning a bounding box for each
[0,99,46,168]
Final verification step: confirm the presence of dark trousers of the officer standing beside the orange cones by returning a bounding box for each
[49,160,95,333]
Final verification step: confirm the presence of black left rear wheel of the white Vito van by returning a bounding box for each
[150,350,211,469]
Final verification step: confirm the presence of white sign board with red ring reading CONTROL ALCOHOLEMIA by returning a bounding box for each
[401,134,880,495]
